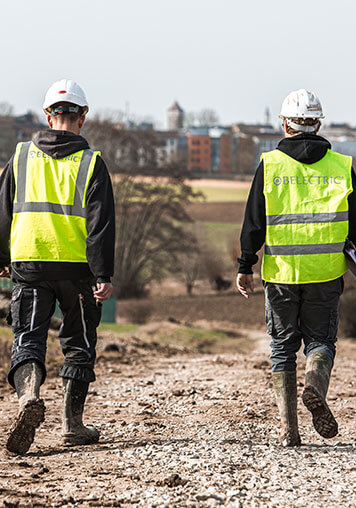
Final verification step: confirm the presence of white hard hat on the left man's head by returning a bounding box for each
[43,79,89,115]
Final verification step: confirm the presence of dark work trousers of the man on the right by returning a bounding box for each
[263,277,344,372]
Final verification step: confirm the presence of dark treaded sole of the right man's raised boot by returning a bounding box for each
[302,386,339,439]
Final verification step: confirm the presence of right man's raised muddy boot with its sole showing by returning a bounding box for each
[302,353,338,439]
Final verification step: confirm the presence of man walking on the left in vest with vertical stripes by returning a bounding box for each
[0,80,115,454]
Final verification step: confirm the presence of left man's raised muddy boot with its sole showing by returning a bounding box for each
[6,362,45,455]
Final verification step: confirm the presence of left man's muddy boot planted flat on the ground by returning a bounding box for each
[62,378,99,446]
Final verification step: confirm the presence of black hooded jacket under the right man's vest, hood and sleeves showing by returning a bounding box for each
[238,134,356,274]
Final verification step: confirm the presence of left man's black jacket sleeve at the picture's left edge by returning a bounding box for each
[0,157,15,268]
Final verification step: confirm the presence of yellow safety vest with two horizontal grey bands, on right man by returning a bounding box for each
[261,150,352,284]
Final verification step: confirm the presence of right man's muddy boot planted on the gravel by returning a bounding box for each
[272,371,300,447]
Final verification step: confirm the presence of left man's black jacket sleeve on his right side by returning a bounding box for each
[86,157,115,282]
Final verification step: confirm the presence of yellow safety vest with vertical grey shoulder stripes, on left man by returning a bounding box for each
[10,142,100,263]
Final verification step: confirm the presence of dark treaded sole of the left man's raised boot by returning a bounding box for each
[6,399,46,455]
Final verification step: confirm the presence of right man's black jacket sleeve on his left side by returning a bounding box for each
[237,161,266,274]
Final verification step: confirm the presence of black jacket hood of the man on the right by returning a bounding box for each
[277,134,331,164]
